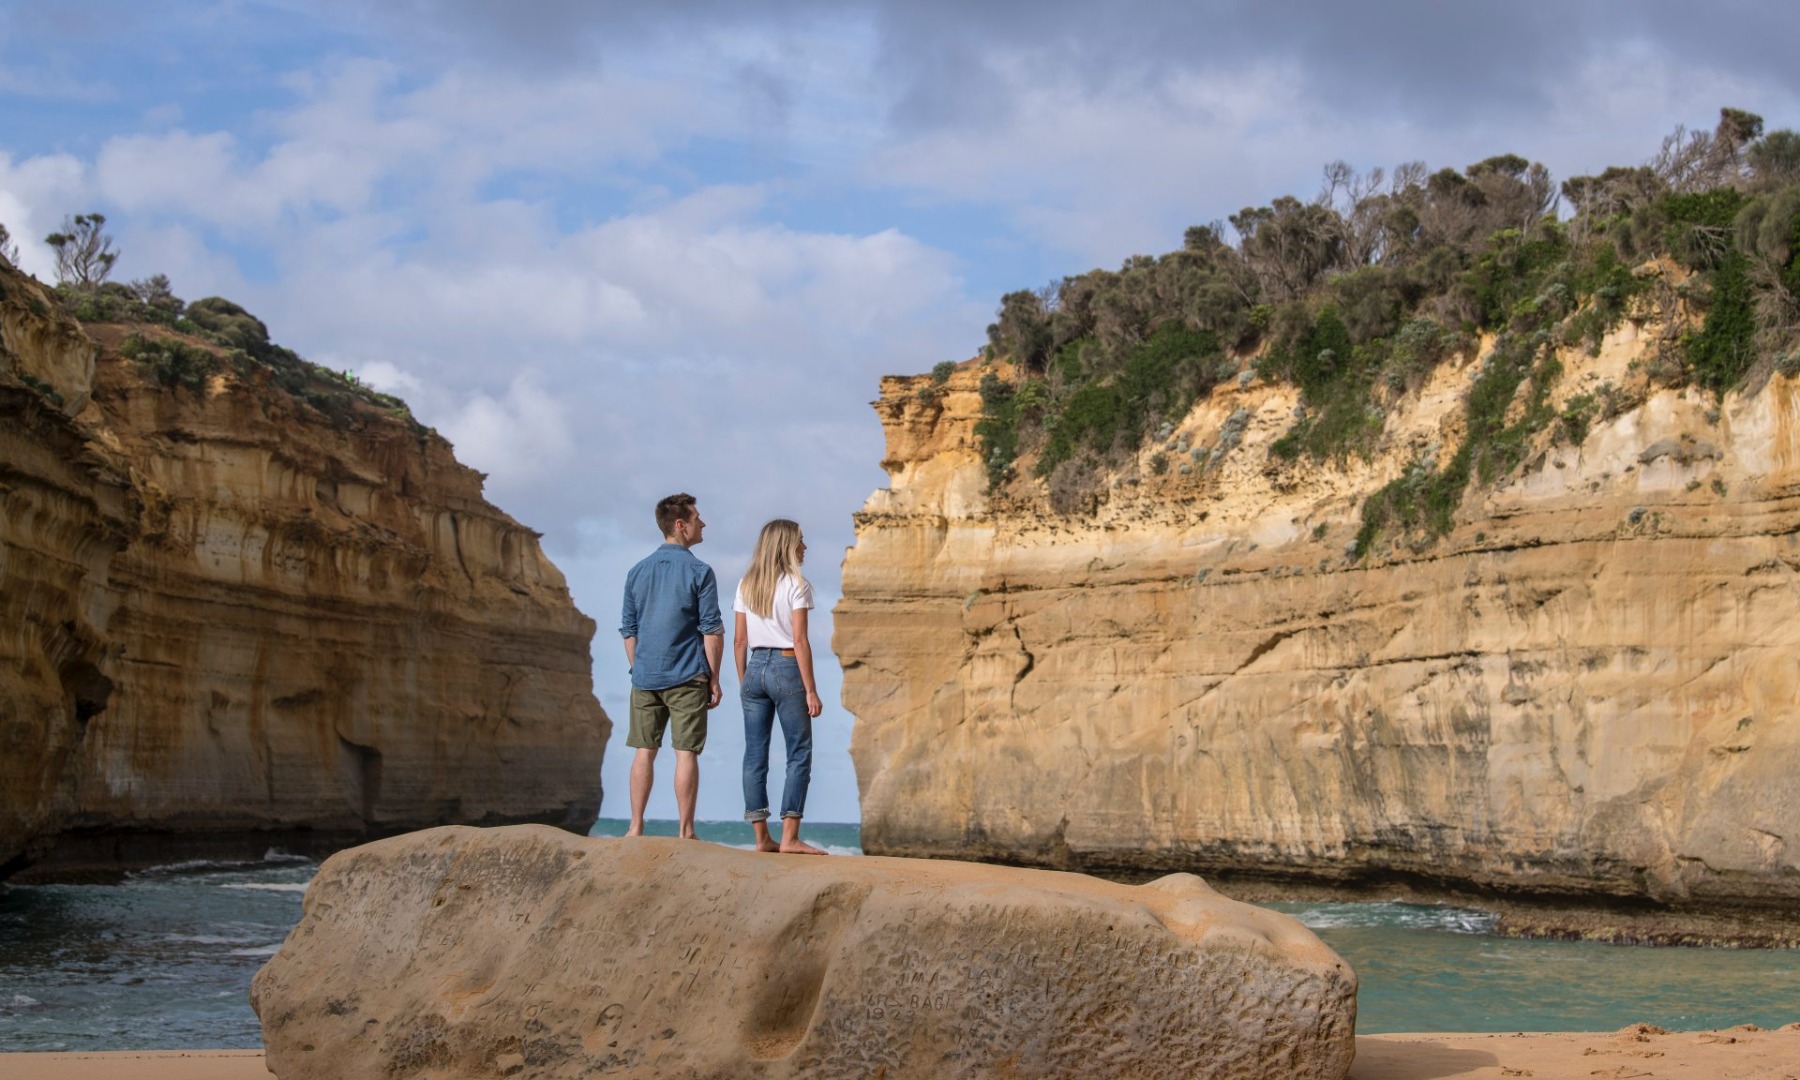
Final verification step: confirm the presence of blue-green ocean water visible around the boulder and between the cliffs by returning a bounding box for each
[0,819,1800,1051]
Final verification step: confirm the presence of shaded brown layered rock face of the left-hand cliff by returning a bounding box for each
[0,266,610,871]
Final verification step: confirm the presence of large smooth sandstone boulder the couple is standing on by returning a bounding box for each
[250,826,1355,1080]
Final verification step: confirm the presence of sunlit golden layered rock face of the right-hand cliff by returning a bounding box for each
[833,291,1800,911]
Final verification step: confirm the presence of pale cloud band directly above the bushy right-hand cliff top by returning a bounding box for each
[862,38,1800,268]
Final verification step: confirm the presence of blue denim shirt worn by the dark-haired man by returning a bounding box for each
[619,544,725,689]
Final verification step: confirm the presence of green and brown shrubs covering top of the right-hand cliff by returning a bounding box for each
[977,108,1800,553]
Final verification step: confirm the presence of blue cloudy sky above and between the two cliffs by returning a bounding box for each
[0,0,1800,821]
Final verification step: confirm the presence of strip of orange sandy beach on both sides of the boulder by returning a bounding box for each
[0,1024,1800,1080]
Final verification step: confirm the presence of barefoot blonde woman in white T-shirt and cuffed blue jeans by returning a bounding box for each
[731,518,824,855]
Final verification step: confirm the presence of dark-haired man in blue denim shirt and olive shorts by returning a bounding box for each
[619,493,725,841]
